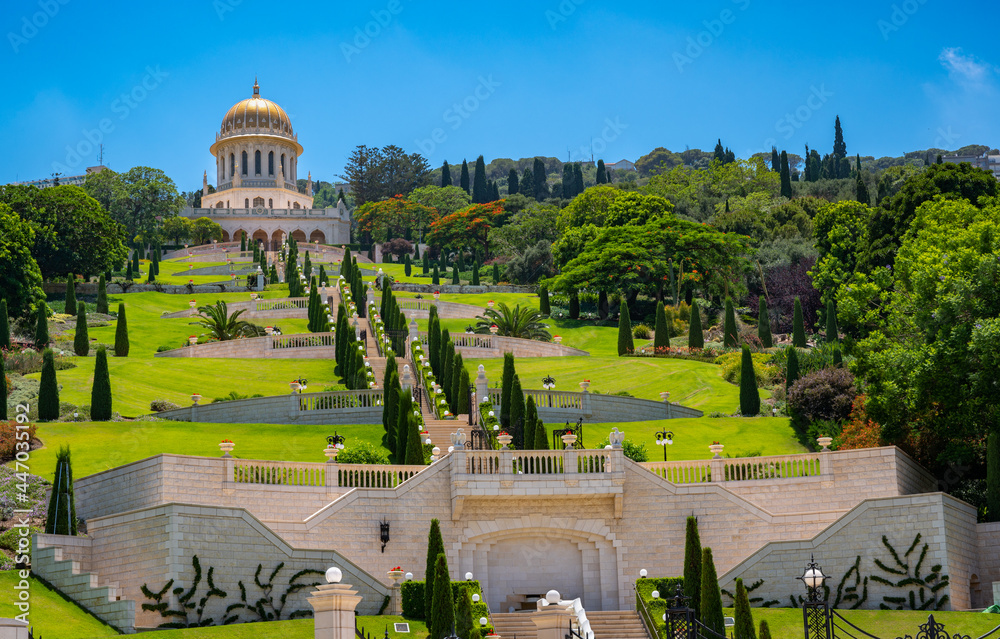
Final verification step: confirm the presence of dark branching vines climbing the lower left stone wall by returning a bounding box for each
[141,555,324,628]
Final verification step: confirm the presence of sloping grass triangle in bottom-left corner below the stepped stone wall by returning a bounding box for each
[0,570,119,639]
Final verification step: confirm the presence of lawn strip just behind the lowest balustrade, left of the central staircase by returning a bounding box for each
[29,421,384,480]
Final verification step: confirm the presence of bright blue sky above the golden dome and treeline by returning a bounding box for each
[0,0,1000,190]
